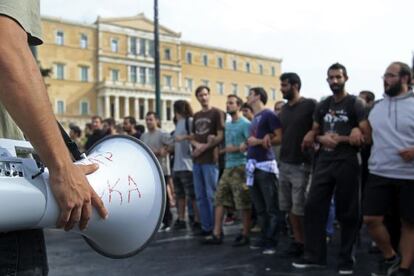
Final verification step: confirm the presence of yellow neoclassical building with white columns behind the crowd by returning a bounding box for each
[38,14,282,129]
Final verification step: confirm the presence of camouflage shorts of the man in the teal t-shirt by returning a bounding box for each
[215,166,252,210]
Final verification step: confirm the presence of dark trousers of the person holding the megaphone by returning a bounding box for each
[0,230,49,276]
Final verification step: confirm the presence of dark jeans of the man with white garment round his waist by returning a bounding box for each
[250,169,281,246]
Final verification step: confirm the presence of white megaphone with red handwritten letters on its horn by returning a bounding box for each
[0,135,166,258]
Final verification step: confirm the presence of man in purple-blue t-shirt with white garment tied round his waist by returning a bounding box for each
[246,87,282,254]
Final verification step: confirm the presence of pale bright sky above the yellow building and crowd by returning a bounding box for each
[41,0,414,101]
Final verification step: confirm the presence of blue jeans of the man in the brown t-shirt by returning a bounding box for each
[193,163,219,232]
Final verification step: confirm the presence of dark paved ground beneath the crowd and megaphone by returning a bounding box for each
[46,222,378,276]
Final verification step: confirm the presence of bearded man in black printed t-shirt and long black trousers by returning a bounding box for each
[293,63,368,275]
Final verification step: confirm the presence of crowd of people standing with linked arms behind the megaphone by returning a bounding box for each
[70,62,414,276]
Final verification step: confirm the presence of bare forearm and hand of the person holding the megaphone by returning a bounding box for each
[0,16,107,230]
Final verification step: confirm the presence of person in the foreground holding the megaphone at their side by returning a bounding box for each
[0,0,107,275]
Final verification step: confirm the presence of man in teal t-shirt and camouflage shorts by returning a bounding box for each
[203,95,252,246]
